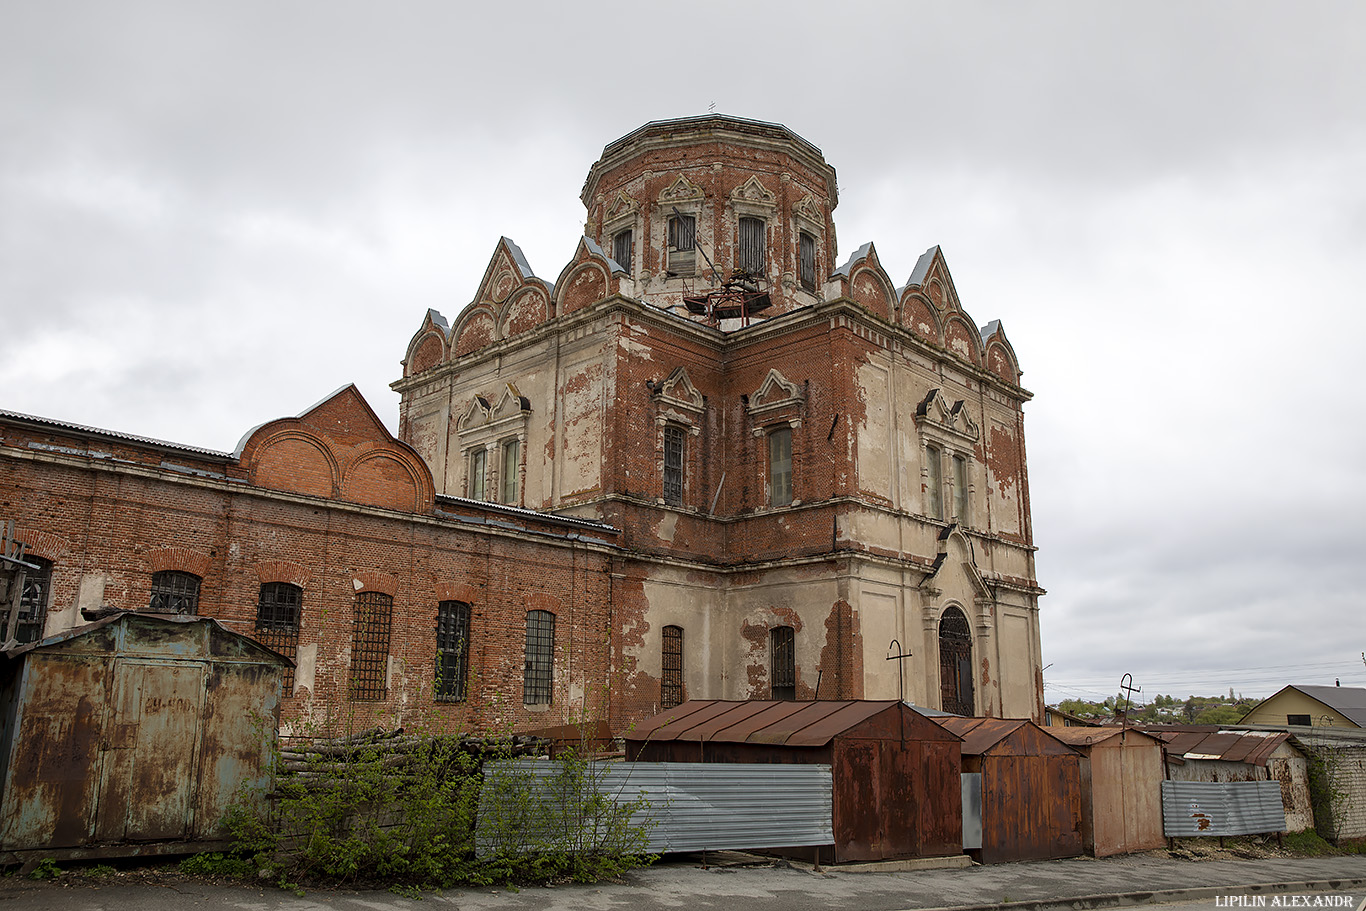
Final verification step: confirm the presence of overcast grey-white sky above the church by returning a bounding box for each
[0,0,1366,702]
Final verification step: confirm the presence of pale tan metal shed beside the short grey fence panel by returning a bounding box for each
[1045,725,1167,858]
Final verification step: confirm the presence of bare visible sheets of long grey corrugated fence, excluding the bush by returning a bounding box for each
[477,759,835,855]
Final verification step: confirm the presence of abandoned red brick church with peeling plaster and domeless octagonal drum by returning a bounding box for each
[0,115,1042,731]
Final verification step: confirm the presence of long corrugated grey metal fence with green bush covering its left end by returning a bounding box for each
[477,759,835,856]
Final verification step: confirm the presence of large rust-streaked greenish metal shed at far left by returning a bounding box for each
[0,613,290,862]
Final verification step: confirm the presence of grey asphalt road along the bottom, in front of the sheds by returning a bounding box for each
[0,852,1366,911]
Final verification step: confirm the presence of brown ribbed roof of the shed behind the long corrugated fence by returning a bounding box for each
[626,699,914,747]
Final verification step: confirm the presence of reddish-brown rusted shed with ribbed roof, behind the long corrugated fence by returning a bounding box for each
[626,699,963,863]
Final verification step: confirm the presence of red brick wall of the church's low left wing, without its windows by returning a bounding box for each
[0,422,612,732]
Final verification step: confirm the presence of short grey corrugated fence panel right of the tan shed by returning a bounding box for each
[1162,781,1285,837]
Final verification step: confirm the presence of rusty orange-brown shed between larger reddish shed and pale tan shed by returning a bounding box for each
[934,717,1082,863]
